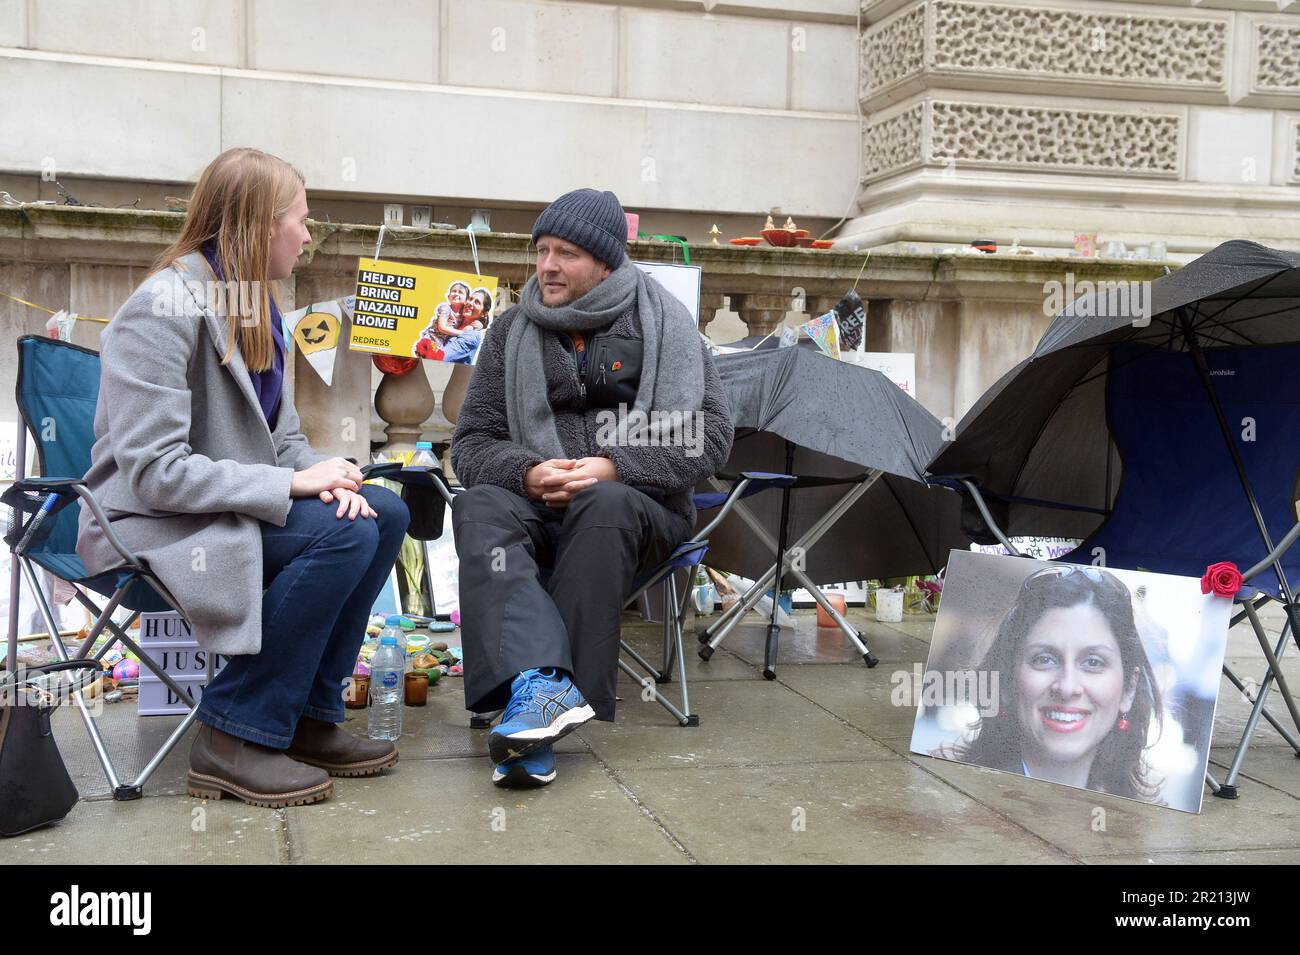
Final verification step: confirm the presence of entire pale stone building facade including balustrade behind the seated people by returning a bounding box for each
[0,0,1300,439]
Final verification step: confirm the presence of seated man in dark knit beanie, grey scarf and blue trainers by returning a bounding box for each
[451,190,732,786]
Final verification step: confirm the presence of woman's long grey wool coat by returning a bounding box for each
[77,252,330,655]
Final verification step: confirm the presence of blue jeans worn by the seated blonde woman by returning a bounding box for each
[198,485,411,750]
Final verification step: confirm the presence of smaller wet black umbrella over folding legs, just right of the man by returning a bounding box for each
[699,347,961,676]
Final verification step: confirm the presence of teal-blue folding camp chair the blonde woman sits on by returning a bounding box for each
[0,335,202,800]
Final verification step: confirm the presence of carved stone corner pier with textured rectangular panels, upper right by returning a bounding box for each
[841,0,1300,259]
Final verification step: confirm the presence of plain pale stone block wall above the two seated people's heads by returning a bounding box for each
[0,0,859,218]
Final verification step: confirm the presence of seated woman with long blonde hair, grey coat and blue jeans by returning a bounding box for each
[77,149,410,807]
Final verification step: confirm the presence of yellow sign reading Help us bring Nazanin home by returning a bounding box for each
[347,259,497,364]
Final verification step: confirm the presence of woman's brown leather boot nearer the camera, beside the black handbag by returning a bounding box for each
[187,724,334,809]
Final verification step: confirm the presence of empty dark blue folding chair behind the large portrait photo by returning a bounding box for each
[935,343,1300,798]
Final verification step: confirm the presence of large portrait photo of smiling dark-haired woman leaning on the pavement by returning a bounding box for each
[911,552,1231,812]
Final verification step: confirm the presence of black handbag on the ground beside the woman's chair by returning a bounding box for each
[0,660,100,835]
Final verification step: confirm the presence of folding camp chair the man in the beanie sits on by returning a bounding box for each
[469,472,794,729]
